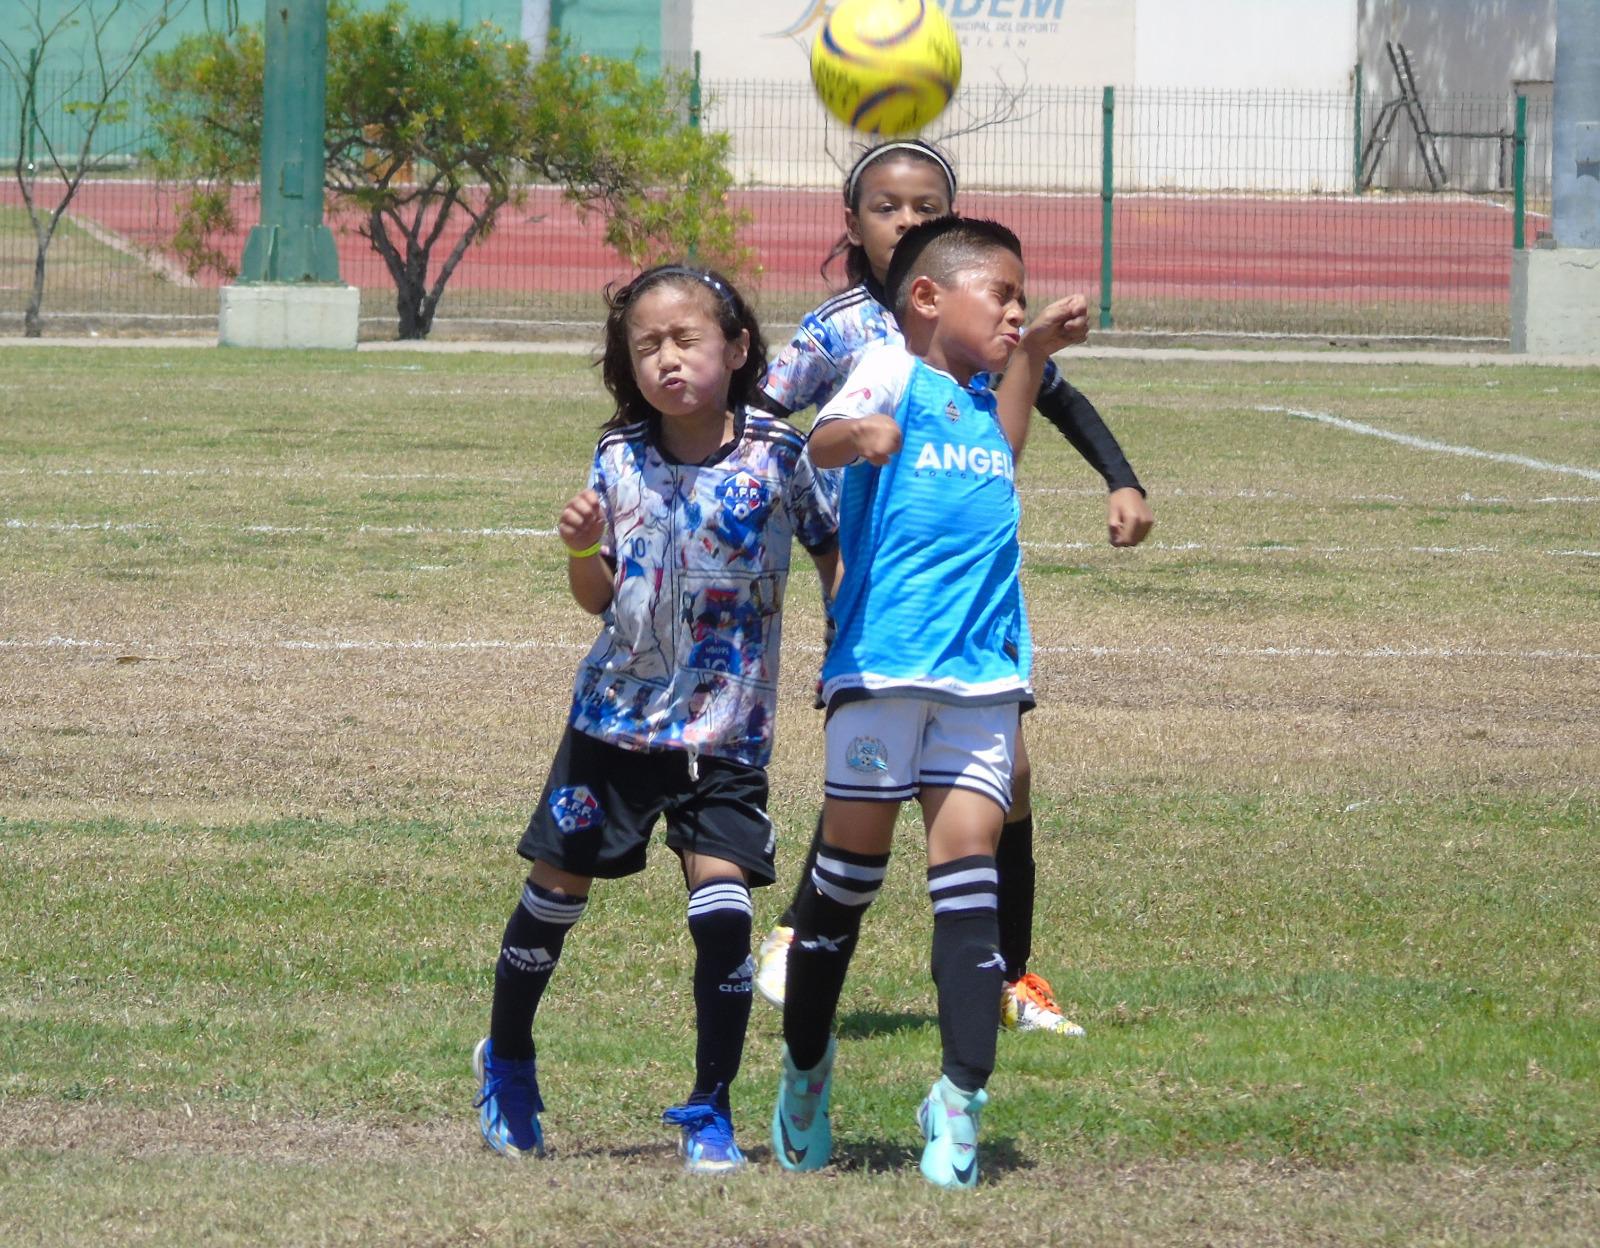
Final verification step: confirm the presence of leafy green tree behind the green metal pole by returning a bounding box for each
[150,0,750,338]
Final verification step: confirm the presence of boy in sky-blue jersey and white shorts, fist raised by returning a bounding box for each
[773,218,1086,1187]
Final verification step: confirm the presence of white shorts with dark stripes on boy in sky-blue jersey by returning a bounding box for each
[824,698,1021,810]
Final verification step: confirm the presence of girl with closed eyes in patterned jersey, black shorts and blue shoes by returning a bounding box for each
[472,266,838,1173]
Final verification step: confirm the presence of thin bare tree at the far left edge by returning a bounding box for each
[0,0,189,338]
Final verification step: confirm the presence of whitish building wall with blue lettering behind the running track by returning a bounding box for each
[688,0,1536,192]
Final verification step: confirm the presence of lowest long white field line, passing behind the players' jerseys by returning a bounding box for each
[0,637,1600,662]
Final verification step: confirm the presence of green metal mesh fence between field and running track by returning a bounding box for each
[0,70,1550,339]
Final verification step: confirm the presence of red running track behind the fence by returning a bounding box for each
[0,181,1534,304]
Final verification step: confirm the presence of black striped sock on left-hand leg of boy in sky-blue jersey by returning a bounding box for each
[784,845,890,1070]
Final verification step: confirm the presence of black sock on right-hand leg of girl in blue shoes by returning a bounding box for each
[690,880,752,1112]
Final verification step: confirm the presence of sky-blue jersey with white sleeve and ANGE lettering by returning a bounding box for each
[811,344,1034,706]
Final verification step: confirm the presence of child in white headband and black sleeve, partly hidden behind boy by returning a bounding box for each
[755,139,1152,1035]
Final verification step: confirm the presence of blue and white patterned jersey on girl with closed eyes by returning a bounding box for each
[571,410,838,766]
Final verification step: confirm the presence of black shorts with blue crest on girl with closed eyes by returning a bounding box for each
[517,726,776,886]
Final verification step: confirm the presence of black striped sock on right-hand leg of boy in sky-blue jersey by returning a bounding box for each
[928,854,1005,1091]
